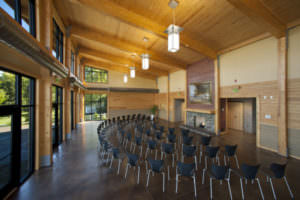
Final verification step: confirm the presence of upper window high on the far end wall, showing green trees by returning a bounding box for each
[84,66,108,83]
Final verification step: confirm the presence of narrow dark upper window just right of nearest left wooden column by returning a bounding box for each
[52,19,64,63]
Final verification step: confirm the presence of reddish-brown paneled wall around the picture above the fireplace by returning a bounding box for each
[187,59,215,110]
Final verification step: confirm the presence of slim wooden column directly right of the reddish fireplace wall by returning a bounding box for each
[214,56,221,135]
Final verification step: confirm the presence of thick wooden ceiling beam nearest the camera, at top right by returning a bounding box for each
[227,0,286,38]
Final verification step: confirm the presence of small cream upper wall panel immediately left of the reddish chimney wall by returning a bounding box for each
[170,70,186,92]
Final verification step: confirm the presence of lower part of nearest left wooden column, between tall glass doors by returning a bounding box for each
[36,78,52,168]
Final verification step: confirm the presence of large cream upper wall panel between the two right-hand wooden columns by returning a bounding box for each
[220,37,278,86]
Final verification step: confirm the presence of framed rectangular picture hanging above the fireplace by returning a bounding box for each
[189,81,212,104]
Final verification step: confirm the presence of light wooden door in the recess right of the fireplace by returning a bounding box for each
[228,102,244,131]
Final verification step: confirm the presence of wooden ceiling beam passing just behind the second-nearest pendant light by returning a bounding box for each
[71,25,187,69]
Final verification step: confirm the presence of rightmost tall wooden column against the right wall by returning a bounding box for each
[278,37,288,156]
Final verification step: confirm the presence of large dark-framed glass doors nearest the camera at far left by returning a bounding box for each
[0,68,35,199]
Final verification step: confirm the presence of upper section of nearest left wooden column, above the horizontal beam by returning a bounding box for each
[37,0,53,51]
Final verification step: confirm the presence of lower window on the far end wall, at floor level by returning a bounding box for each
[84,94,107,121]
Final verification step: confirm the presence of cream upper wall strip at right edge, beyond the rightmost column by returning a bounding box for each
[288,26,300,79]
